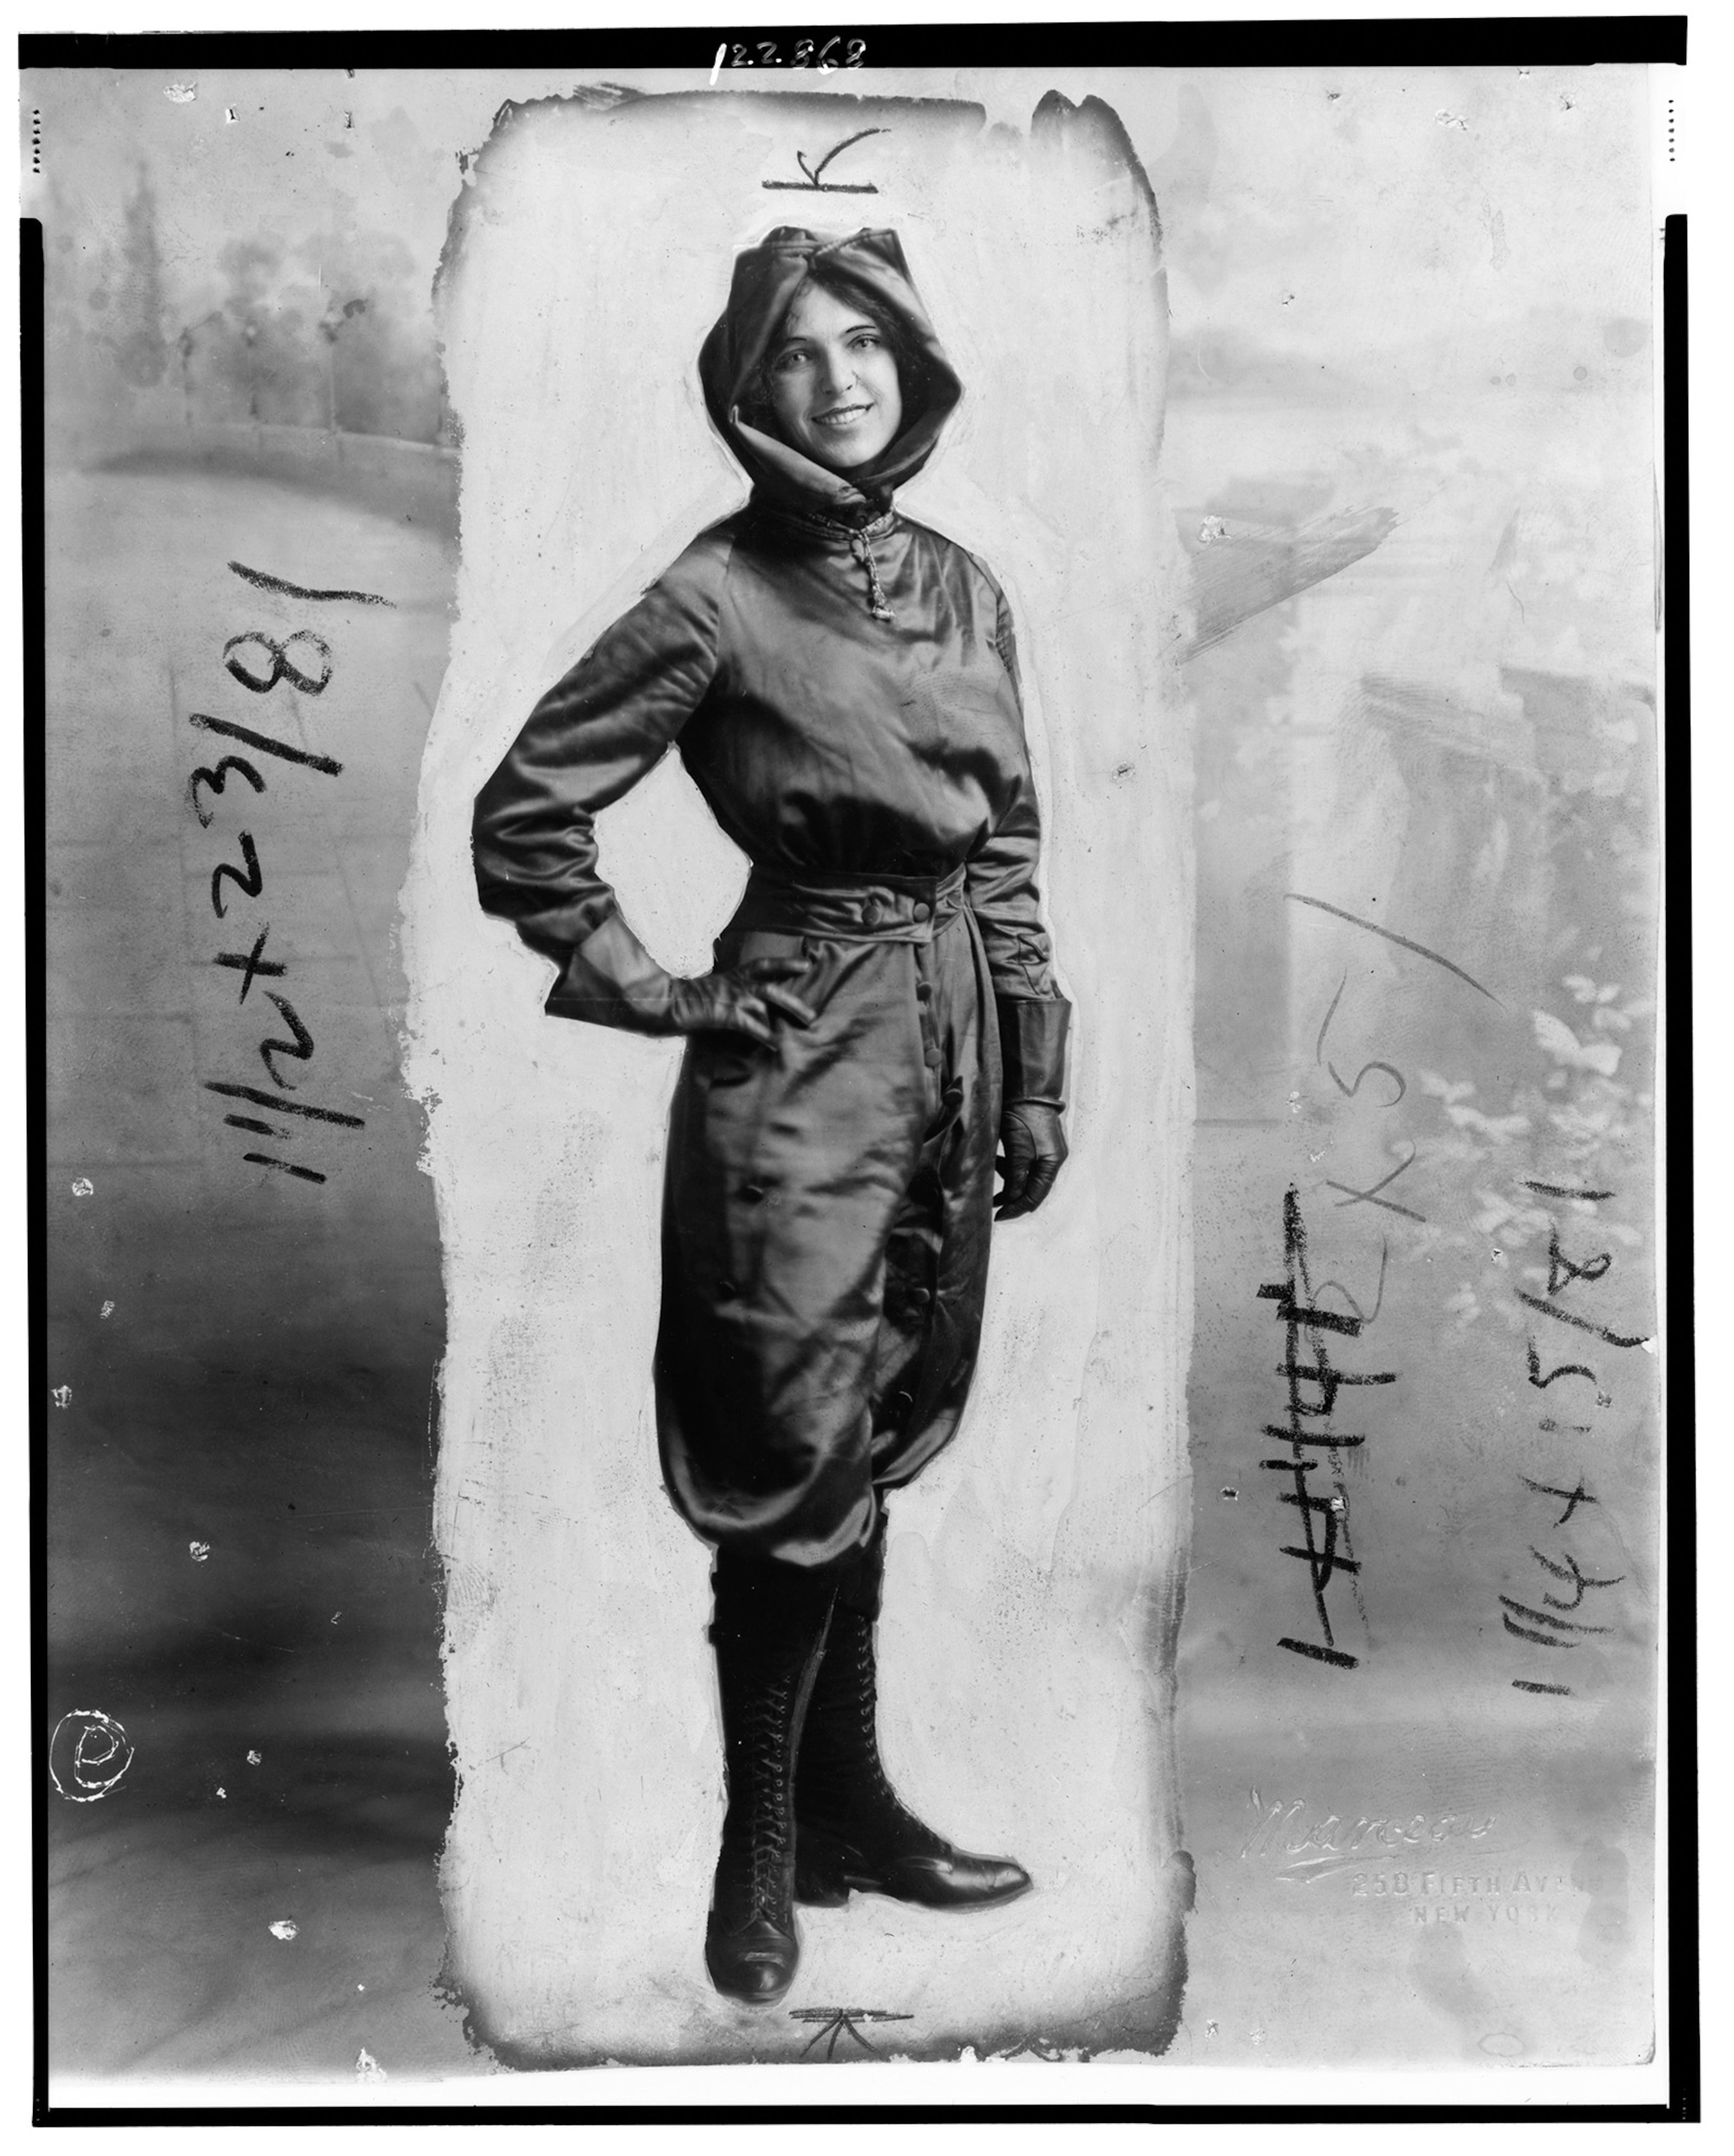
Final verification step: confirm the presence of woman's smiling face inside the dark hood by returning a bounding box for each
[766,285,904,472]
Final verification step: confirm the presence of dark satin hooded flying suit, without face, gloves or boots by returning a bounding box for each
[474,233,1067,1565]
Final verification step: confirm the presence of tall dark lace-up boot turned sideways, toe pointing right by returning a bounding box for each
[796,1533,1031,1908]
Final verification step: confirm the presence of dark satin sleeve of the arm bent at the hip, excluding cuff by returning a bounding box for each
[472,539,727,959]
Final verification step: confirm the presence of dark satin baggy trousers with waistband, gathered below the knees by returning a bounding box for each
[655,871,1001,1567]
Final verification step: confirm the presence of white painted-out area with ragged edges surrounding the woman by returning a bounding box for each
[404,78,1191,2063]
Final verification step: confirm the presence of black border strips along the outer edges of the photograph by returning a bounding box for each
[20,15,1702,2126]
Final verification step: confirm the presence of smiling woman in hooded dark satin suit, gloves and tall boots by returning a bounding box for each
[474,229,1069,2005]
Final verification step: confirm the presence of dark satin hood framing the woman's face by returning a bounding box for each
[699,224,964,519]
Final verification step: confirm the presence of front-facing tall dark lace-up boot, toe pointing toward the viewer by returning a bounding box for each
[705,1552,834,2005]
